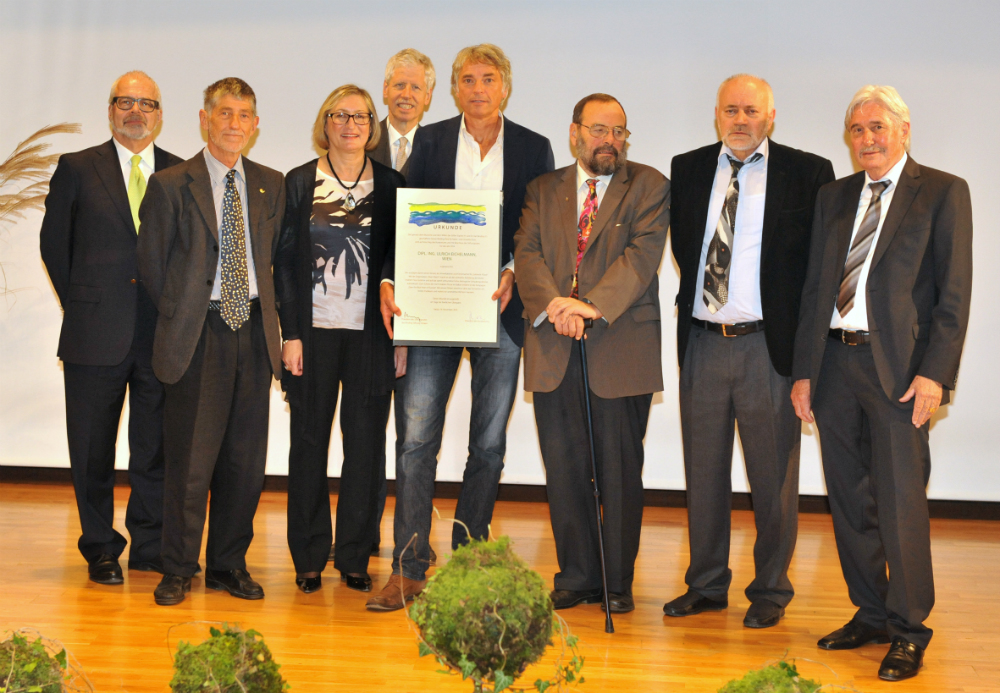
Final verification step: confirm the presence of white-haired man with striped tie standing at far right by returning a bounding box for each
[792,85,972,681]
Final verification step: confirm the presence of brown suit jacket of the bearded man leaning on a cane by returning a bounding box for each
[514,162,670,399]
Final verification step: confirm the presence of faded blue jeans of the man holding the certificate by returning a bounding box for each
[392,326,521,580]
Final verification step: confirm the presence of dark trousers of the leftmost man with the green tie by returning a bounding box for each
[63,341,163,562]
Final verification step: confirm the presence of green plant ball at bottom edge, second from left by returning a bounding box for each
[170,624,289,693]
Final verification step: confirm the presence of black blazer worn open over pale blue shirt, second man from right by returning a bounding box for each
[670,141,835,376]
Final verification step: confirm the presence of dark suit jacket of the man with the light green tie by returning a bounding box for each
[40,140,182,366]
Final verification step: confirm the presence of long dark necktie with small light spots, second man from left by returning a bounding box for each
[219,170,250,332]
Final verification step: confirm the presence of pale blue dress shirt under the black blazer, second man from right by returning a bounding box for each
[693,137,768,325]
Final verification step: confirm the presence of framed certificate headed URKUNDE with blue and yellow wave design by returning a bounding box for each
[393,188,502,347]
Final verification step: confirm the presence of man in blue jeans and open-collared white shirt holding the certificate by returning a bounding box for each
[368,43,555,611]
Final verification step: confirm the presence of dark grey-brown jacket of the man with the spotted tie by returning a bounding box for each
[139,151,285,385]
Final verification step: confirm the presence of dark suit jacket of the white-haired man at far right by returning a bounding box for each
[792,157,972,407]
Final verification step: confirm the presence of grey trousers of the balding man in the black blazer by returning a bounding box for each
[680,326,802,606]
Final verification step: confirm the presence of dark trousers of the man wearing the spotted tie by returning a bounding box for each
[163,303,271,577]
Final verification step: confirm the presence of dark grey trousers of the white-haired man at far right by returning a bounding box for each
[812,339,934,647]
